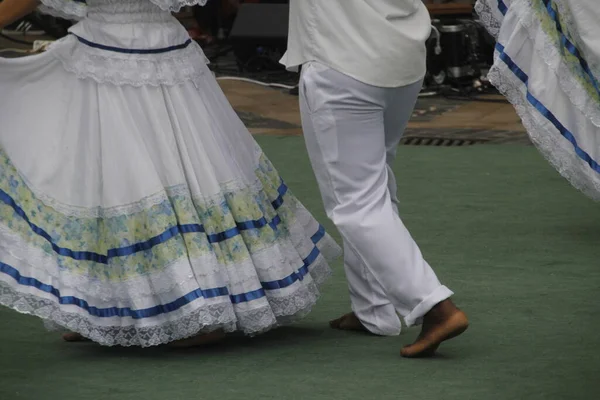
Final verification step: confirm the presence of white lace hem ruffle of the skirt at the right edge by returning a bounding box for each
[489,56,600,201]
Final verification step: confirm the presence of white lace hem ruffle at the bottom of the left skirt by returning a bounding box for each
[0,271,320,347]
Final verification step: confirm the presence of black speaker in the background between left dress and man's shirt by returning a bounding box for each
[229,4,290,72]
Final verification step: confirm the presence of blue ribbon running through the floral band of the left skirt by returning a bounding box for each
[0,182,288,264]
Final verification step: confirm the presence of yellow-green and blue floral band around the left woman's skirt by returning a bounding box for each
[0,151,314,281]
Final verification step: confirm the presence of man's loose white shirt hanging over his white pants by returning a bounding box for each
[281,0,431,87]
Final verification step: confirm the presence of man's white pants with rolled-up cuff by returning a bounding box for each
[300,62,453,335]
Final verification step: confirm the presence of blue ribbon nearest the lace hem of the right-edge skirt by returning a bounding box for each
[496,43,600,173]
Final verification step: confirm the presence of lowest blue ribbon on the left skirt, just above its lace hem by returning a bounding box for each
[0,225,325,319]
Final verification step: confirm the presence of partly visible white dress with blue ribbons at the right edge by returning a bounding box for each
[476,0,600,200]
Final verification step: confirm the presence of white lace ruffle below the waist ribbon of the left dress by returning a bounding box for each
[48,36,210,87]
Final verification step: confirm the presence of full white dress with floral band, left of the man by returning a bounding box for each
[0,0,340,346]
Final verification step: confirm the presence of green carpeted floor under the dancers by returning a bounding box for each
[0,137,600,400]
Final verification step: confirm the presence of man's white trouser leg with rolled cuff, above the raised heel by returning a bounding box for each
[300,64,466,356]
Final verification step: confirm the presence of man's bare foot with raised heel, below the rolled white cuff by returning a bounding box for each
[400,299,469,358]
